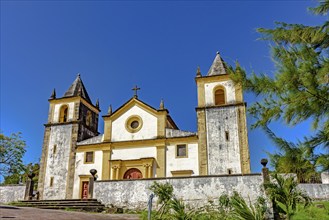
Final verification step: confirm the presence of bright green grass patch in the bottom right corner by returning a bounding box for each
[292,201,329,220]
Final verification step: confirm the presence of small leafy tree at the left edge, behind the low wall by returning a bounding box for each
[0,133,26,180]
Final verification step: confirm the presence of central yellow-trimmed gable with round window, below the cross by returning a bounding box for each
[103,97,177,142]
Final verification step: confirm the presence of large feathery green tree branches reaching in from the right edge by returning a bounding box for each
[229,0,329,170]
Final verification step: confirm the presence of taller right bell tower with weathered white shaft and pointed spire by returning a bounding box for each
[195,52,250,175]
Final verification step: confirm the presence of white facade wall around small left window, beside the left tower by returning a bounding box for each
[73,151,103,199]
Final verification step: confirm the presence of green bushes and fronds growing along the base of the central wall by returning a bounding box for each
[142,182,267,220]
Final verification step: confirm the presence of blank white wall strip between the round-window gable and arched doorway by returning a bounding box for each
[111,146,157,160]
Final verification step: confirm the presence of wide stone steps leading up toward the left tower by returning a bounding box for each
[12,199,105,212]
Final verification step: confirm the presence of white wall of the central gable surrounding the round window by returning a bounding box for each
[111,105,158,141]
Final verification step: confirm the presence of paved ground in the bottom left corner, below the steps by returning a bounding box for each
[0,205,139,220]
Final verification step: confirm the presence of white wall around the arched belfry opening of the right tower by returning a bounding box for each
[204,80,235,106]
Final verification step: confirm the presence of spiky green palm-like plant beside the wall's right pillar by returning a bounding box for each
[264,173,311,219]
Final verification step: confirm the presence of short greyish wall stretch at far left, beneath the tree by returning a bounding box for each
[0,185,25,203]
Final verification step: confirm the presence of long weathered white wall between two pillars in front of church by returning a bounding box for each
[94,174,264,209]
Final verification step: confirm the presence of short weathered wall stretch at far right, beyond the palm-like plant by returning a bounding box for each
[298,184,329,201]
